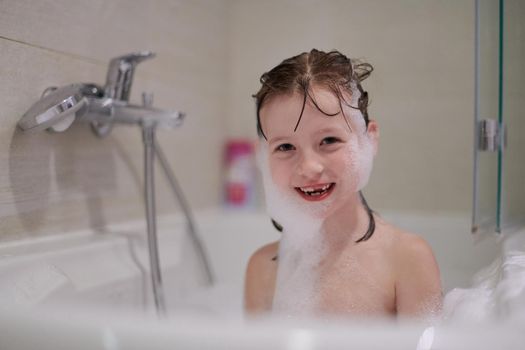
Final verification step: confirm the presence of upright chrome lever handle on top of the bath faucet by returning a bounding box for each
[104,51,155,101]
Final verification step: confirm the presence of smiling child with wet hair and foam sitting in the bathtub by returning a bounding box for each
[245,49,442,317]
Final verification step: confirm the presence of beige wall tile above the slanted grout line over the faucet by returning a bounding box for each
[0,0,226,64]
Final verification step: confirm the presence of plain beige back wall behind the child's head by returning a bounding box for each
[228,0,474,211]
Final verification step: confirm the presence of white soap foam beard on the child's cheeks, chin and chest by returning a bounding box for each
[257,112,373,317]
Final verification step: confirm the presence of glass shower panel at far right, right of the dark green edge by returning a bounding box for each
[499,0,525,231]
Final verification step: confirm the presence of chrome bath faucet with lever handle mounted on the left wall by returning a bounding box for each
[18,51,184,137]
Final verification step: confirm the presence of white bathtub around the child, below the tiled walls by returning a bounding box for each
[0,210,525,350]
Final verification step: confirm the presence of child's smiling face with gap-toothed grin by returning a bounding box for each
[260,89,378,217]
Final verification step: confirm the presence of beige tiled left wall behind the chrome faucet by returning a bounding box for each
[0,0,228,240]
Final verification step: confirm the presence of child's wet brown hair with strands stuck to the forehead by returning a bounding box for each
[253,49,375,242]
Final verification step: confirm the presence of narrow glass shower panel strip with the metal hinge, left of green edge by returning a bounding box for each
[472,0,500,234]
